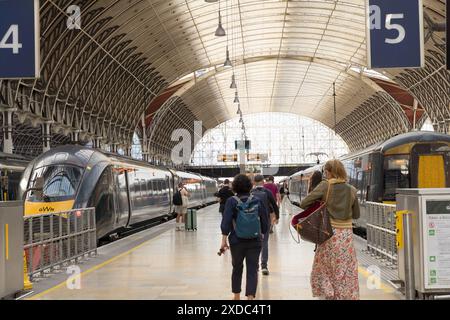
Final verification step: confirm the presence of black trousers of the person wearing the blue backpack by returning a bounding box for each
[230,240,262,296]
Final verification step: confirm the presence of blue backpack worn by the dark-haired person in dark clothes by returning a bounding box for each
[233,195,261,239]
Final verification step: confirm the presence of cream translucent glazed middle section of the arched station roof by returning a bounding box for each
[136,0,375,128]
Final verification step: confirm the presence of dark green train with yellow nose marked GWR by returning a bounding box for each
[19,145,217,239]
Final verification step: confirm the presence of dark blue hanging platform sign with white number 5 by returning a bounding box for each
[366,0,425,68]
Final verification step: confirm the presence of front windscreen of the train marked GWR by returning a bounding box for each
[27,165,83,202]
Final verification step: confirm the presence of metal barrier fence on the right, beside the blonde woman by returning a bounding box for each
[366,202,397,266]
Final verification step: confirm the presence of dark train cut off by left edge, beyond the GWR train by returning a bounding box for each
[0,152,30,201]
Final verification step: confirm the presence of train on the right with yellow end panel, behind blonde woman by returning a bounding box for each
[289,131,450,235]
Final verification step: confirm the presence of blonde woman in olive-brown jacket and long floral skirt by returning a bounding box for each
[300,160,360,300]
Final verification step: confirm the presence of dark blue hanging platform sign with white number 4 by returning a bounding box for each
[0,0,40,79]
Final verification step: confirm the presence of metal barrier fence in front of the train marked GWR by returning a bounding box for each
[24,208,97,279]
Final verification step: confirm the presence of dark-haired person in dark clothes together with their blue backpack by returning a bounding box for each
[220,174,269,300]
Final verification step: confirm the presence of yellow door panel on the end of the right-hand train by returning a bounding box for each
[417,154,446,188]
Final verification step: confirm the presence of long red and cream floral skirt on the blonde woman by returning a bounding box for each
[311,229,359,300]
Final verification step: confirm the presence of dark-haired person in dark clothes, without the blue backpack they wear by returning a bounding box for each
[220,174,269,300]
